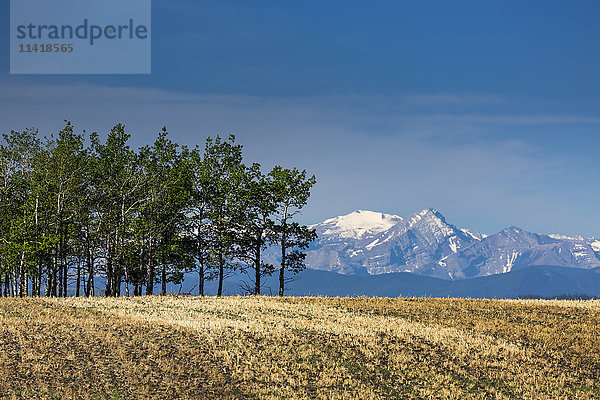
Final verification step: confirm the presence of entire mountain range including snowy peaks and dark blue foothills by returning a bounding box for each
[157,208,600,298]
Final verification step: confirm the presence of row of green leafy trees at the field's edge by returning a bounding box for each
[0,122,316,296]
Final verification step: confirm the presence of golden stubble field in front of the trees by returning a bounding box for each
[0,296,600,399]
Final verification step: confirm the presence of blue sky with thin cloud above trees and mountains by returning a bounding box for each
[0,0,600,236]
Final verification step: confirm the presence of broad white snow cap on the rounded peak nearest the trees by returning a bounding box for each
[311,210,402,239]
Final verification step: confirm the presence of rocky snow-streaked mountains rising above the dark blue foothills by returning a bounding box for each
[306,208,600,279]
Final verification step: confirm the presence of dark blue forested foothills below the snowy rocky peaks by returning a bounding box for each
[164,265,600,298]
